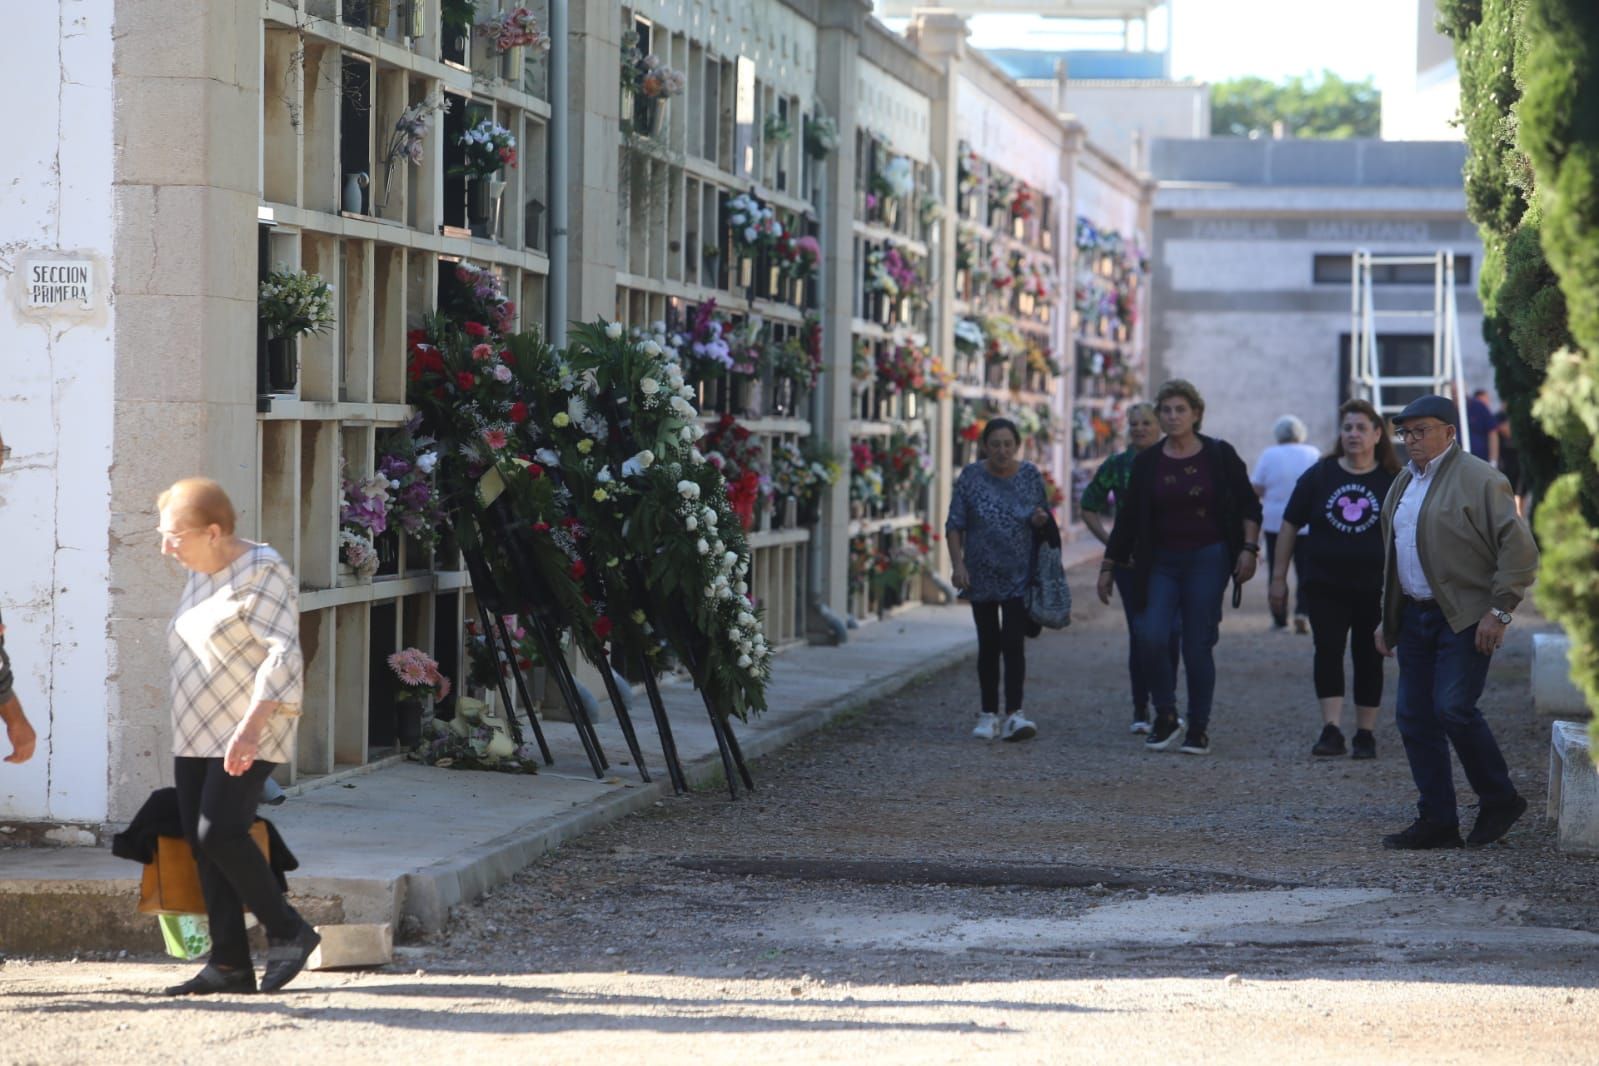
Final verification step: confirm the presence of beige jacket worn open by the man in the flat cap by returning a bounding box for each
[1383,444,1538,647]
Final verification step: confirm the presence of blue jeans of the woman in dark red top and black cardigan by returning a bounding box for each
[1134,543,1233,732]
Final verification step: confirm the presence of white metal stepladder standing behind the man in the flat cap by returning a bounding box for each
[1350,249,1471,449]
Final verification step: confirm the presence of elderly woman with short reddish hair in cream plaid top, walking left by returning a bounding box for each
[158,478,321,996]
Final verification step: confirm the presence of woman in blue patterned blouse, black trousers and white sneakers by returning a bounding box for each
[943,419,1049,740]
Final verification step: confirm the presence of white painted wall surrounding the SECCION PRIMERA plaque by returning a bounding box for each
[0,0,114,821]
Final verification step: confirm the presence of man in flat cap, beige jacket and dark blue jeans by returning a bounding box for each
[1377,396,1538,850]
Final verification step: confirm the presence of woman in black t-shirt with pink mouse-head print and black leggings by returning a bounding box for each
[1268,400,1399,759]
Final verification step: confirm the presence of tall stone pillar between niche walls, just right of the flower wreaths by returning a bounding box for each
[807,0,871,639]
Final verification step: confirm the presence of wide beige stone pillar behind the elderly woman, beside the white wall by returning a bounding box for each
[106,0,262,820]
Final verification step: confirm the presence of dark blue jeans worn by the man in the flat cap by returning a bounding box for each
[1394,603,1516,825]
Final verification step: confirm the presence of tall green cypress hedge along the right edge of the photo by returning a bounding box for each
[1439,0,1599,743]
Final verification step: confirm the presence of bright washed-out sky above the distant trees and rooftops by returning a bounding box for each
[892,0,1415,82]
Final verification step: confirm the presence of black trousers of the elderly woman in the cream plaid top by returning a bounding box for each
[173,756,301,969]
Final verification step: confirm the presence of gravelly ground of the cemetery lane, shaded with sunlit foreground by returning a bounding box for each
[0,572,1599,1063]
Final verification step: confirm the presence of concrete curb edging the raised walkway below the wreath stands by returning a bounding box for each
[393,642,977,933]
